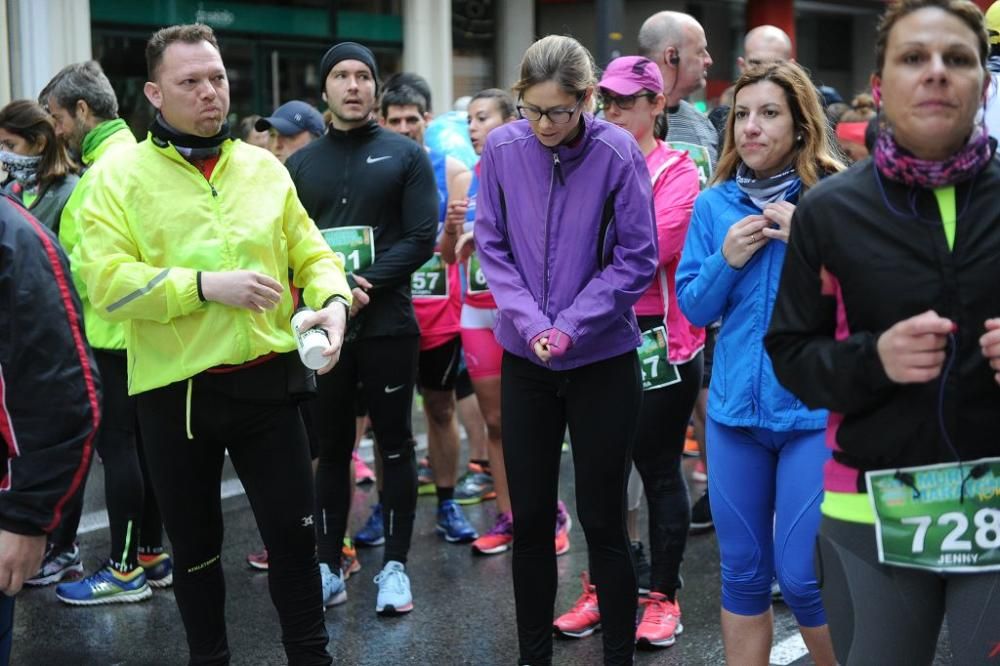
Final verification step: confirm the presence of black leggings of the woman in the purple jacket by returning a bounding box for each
[501,352,642,664]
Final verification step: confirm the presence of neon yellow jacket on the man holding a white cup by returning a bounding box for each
[78,138,351,395]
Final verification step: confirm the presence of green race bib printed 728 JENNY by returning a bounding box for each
[865,458,1000,572]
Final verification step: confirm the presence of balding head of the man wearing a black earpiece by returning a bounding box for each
[638,11,712,106]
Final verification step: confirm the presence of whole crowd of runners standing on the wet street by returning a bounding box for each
[0,0,1000,666]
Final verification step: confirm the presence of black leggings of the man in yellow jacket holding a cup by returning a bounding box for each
[138,355,332,664]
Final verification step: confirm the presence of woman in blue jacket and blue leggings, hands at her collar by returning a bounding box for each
[677,63,843,666]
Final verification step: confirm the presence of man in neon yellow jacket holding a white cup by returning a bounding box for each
[79,24,351,664]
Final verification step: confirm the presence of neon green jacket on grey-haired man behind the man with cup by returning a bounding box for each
[59,120,135,349]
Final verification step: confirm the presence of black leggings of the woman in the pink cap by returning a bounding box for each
[632,317,703,600]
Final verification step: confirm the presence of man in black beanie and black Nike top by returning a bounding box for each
[287,42,438,615]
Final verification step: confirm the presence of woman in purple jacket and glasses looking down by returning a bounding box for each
[476,35,658,664]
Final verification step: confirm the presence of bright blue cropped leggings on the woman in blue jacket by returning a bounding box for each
[706,417,830,627]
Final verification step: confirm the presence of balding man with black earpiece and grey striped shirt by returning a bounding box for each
[639,11,719,188]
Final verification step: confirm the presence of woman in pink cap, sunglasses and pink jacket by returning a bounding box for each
[555,56,705,647]
